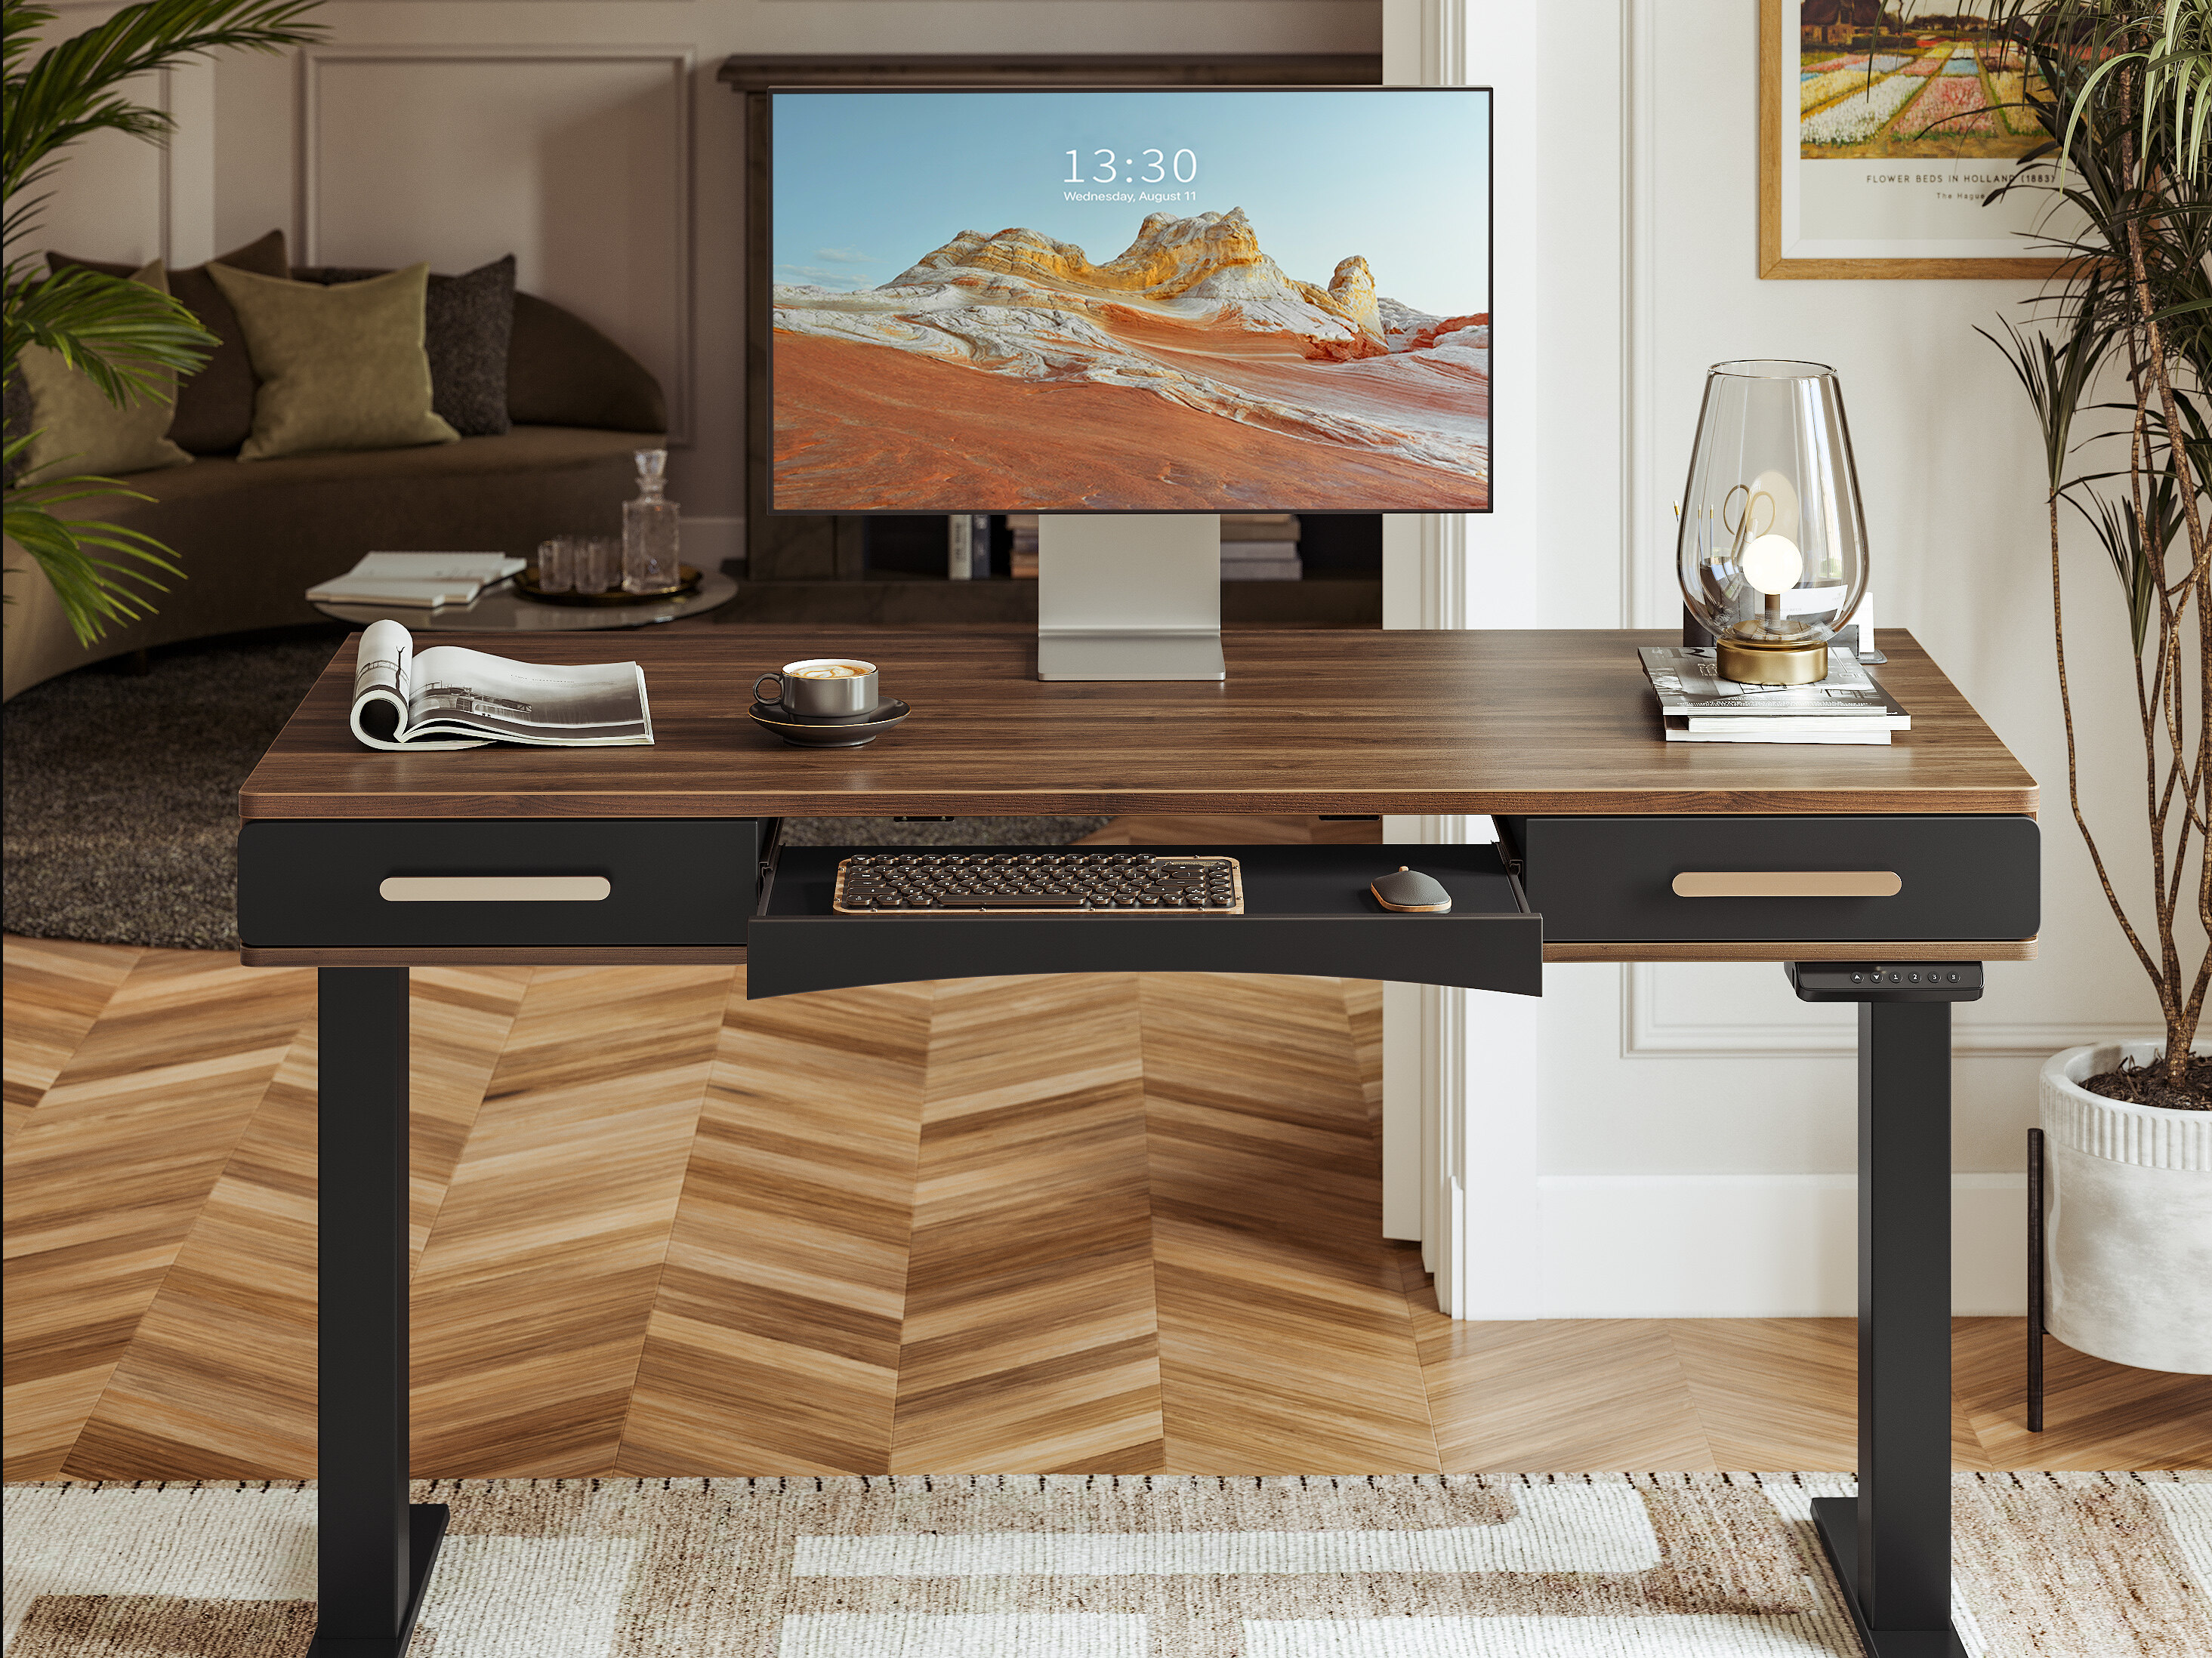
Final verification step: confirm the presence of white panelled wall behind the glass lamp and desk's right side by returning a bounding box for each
[1416,0,2157,1317]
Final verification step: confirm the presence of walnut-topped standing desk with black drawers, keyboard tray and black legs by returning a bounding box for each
[239,628,2040,1658]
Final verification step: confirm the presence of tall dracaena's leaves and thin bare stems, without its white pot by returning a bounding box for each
[1984,0,2212,1110]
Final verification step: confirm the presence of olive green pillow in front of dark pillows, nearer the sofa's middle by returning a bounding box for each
[208,263,460,460]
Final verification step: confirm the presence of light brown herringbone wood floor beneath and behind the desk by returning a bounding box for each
[5,820,2212,1479]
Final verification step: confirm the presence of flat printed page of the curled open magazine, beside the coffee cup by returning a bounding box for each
[407,646,652,747]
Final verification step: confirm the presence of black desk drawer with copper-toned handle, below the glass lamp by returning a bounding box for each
[1498,814,2041,944]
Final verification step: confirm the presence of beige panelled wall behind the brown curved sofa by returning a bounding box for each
[42,0,1383,559]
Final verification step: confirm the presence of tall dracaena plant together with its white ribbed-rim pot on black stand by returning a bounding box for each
[1988,0,2212,1426]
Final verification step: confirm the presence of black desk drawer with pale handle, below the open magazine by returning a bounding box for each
[239,818,761,948]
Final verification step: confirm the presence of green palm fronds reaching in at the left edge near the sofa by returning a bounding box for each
[0,0,319,643]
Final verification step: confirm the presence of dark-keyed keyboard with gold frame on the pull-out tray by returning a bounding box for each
[831,851,1243,915]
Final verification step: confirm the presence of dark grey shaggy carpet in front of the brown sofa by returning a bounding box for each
[0,630,1106,951]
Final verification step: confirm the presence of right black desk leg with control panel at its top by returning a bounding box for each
[1791,962,1982,1658]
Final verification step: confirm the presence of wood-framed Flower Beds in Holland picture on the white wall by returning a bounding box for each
[1759,0,2064,279]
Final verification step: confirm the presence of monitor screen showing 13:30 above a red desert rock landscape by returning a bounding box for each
[770,86,1491,513]
